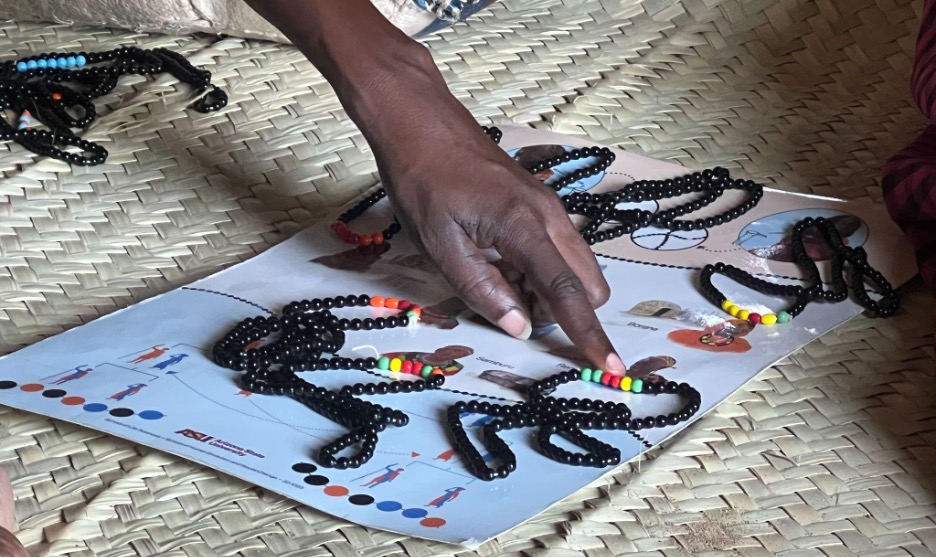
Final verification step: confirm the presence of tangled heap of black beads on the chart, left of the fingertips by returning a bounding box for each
[212,295,445,469]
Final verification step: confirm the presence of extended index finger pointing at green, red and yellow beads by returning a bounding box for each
[496,228,626,374]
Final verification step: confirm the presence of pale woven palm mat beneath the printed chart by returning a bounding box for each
[0,0,936,556]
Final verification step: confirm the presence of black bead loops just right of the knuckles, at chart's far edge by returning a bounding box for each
[562,167,764,245]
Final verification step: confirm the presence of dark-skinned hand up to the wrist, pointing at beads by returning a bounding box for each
[355,51,625,374]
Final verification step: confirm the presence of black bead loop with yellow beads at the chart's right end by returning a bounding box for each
[699,217,900,324]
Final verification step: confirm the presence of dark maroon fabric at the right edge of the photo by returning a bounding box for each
[882,0,936,291]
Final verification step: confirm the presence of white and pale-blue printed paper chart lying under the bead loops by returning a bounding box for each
[0,129,914,547]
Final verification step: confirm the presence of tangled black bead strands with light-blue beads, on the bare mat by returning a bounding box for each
[0,46,228,166]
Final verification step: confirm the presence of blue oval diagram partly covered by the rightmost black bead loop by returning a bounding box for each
[734,209,868,262]
